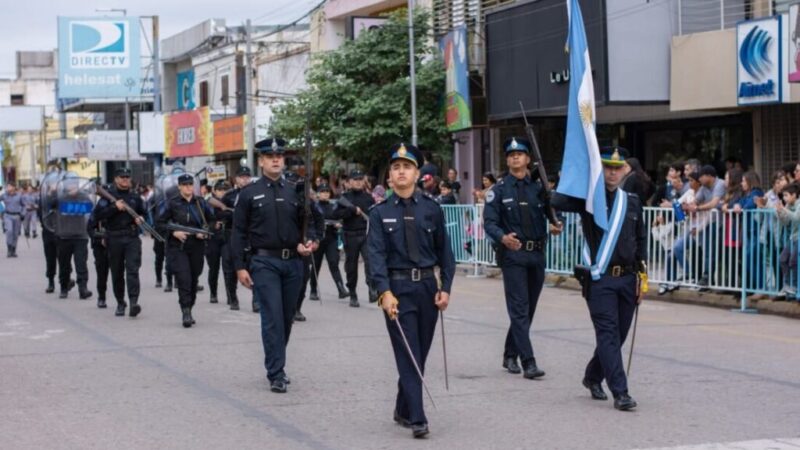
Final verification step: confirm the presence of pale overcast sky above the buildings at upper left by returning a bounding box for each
[0,0,320,78]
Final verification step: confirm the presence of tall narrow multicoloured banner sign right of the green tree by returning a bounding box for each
[439,25,472,131]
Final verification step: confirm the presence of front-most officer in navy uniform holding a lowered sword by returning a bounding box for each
[367,144,455,438]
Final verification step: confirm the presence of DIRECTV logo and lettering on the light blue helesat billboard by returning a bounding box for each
[69,20,130,69]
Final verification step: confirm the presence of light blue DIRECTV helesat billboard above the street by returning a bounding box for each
[58,17,141,98]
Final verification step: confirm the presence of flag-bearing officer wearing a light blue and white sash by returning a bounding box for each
[552,148,647,411]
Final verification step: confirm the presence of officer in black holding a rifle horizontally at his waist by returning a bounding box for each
[157,173,215,328]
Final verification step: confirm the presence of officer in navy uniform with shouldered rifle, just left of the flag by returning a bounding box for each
[483,137,559,379]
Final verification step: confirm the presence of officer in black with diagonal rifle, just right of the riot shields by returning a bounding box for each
[92,167,146,317]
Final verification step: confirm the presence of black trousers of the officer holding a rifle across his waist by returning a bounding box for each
[167,236,206,308]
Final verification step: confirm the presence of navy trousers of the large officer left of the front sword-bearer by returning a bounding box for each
[250,255,303,382]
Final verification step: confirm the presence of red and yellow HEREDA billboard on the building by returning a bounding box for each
[164,107,214,158]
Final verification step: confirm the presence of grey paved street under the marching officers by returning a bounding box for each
[0,239,800,449]
